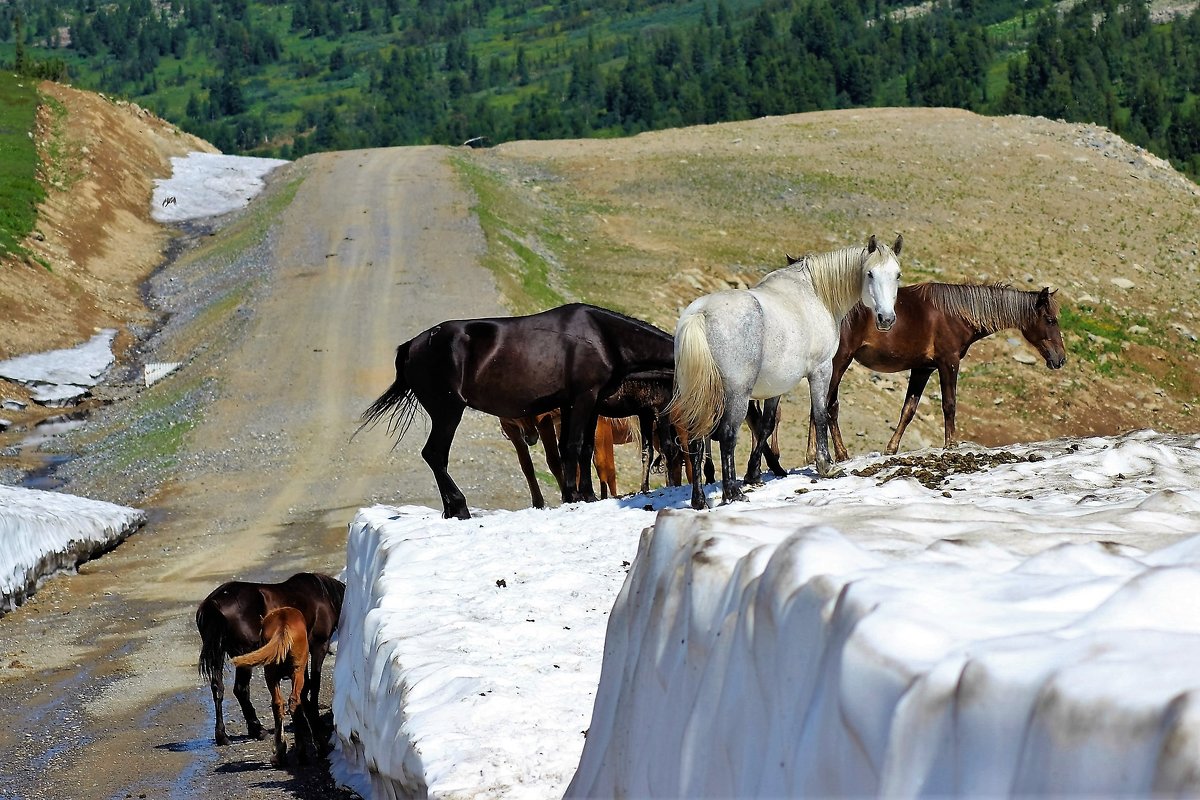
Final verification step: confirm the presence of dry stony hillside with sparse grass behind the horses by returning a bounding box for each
[456,109,1200,463]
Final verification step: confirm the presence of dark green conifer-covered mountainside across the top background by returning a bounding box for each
[7,0,1200,178]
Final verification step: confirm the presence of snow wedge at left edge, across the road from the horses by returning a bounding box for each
[0,485,145,612]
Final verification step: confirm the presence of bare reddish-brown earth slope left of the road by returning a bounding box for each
[0,82,215,357]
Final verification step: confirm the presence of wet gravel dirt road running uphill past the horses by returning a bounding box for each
[0,148,527,799]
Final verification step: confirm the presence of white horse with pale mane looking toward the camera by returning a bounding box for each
[671,236,904,509]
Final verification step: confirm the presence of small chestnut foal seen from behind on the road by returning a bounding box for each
[230,606,316,766]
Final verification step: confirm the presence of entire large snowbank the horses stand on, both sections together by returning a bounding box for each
[334,432,1200,798]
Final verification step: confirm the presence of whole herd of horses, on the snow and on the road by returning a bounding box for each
[196,236,1066,763]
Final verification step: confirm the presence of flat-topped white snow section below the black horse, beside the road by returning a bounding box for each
[334,500,654,798]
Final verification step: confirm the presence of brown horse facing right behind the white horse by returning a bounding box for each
[809,283,1067,461]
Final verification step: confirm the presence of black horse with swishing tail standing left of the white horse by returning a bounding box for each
[359,303,674,519]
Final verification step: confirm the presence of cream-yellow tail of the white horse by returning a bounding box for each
[667,312,725,438]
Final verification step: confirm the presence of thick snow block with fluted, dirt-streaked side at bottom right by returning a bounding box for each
[568,434,1200,798]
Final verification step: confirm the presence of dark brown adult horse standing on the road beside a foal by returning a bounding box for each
[196,572,346,745]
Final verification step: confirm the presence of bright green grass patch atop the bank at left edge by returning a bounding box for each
[0,72,46,257]
